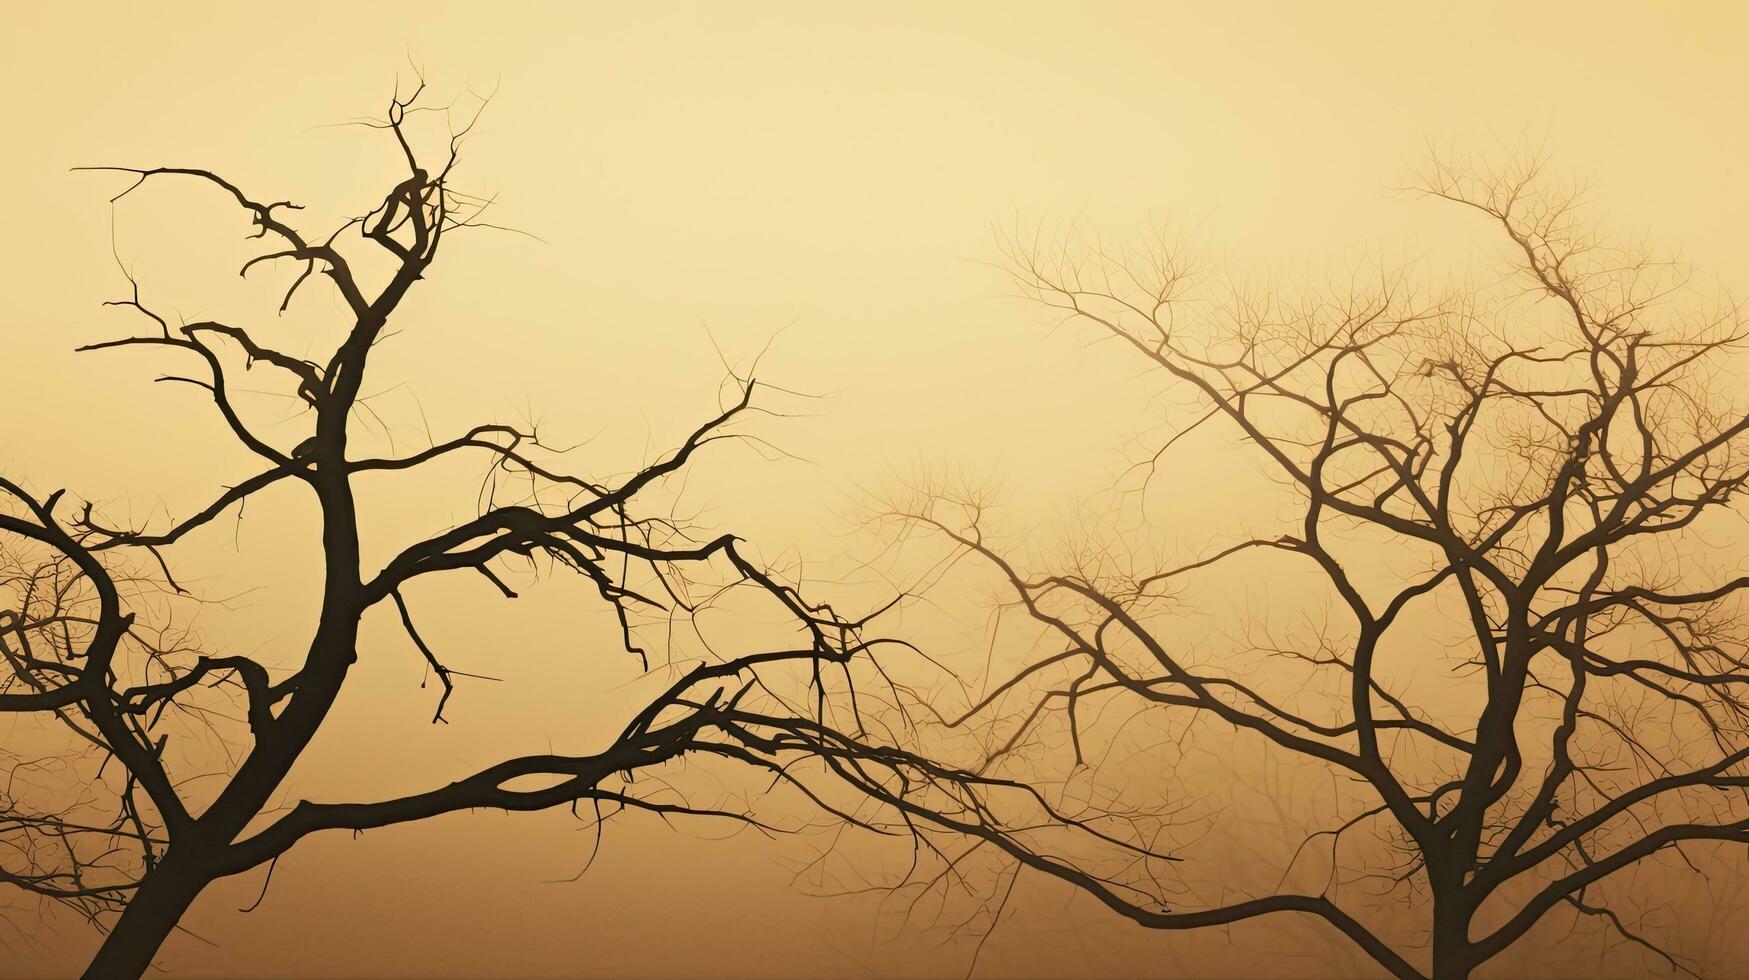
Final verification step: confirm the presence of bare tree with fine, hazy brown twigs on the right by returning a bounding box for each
[867,161,1749,978]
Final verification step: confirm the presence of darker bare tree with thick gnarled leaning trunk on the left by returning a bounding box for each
[0,84,958,977]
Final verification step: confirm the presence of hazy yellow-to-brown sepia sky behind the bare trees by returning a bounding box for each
[0,2,1749,977]
